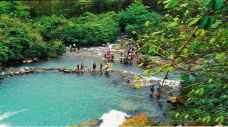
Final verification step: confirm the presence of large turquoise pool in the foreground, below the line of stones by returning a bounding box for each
[0,72,165,126]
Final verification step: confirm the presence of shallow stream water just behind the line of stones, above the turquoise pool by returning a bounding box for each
[19,51,180,80]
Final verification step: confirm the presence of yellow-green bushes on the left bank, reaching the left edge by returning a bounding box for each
[0,1,64,66]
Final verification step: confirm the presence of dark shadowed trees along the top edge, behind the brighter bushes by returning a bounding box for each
[24,0,134,18]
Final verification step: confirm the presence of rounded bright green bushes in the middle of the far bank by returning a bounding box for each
[62,12,119,46]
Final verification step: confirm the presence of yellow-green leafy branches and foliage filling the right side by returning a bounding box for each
[134,0,228,125]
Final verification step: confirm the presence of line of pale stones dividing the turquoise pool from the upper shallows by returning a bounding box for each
[0,67,180,93]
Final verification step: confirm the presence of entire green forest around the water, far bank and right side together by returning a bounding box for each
[0,0,228,125]
